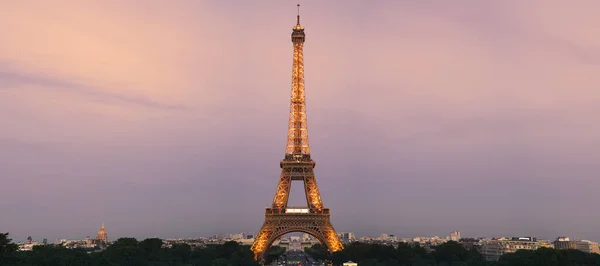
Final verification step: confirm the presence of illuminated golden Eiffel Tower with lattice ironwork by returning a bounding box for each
[251,5,343,261]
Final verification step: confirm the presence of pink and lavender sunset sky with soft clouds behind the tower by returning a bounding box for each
[0,0,600,241]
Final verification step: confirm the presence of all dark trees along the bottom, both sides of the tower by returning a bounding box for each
[0,233,600,266]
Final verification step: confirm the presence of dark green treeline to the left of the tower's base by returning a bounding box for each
[0,234,284,266]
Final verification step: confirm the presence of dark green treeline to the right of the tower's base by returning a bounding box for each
[305,241,600,266]
